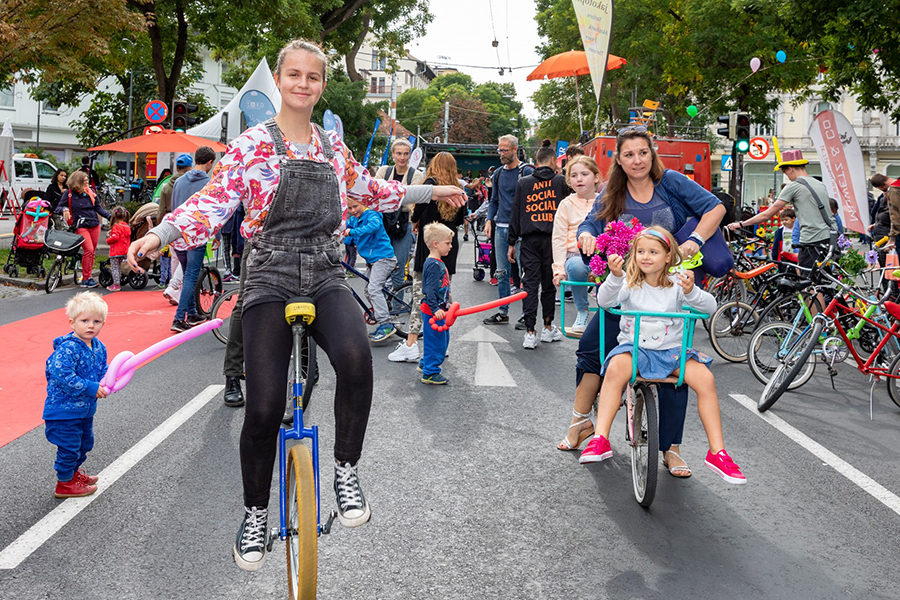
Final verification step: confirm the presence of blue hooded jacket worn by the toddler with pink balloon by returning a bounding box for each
[44,331,107,420]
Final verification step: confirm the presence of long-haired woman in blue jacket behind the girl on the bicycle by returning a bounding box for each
[558,127,725,477]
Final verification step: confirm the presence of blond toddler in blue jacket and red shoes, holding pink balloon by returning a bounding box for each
[44,292,108,498]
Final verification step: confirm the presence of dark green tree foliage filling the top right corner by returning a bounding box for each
[780,0,900,122]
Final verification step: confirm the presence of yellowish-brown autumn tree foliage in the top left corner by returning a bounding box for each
[0,0,143,86]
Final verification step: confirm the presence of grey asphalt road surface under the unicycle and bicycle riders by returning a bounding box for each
[0,244,900,600]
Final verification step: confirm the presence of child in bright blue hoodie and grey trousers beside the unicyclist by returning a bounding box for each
[344,198,397,343]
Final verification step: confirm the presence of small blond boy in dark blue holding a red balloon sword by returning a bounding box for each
[419,223,453,385]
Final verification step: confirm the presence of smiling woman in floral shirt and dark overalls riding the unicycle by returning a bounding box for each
[128,40,466,571]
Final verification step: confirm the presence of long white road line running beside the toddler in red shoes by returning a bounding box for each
[0,385,225,569]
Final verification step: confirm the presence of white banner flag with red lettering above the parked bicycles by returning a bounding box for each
[809,110,869,234]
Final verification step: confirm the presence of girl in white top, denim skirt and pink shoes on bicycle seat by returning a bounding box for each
[578,227,747,484]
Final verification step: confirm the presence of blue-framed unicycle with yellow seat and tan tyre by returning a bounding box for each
[268,296,337,600]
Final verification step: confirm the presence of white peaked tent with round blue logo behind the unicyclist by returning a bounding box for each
[187,58,281,143]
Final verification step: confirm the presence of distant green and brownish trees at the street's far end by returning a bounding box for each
[397,73,528,144]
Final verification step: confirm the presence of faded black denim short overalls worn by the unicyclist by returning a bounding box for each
[243,119,347,310]
